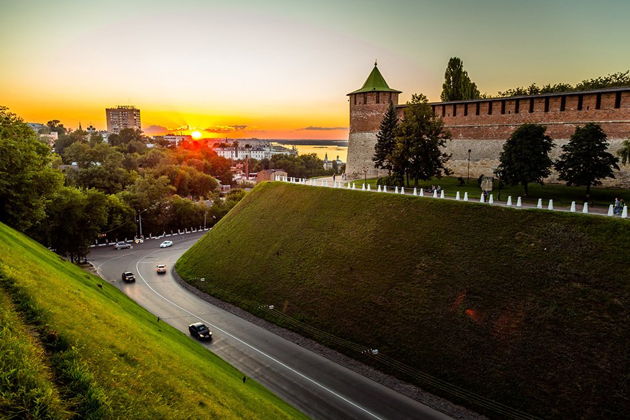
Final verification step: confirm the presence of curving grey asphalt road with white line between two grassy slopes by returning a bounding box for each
[89,233,449,419]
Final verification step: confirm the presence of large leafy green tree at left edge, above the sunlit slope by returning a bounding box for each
[0,106,63,231]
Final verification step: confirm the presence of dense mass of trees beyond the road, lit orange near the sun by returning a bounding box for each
[0,107,244,261]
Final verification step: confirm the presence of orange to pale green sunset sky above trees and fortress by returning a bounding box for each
[0,0,630,139]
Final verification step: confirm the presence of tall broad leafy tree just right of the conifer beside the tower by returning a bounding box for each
[392,94,451,185]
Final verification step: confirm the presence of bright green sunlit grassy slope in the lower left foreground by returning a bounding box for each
[0,224,303,419]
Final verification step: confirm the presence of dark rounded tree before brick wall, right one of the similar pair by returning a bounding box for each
[555,123,619,197]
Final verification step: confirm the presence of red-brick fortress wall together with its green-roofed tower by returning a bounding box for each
[346,66,630,186]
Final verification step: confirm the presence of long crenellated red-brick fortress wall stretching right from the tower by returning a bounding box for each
[390,88,630,187]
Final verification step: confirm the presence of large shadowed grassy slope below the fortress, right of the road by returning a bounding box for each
[177,183,630,418]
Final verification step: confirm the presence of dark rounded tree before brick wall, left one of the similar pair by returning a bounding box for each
[495,124,553,196]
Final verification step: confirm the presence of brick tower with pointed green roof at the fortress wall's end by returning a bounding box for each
[346,63,401,178]
